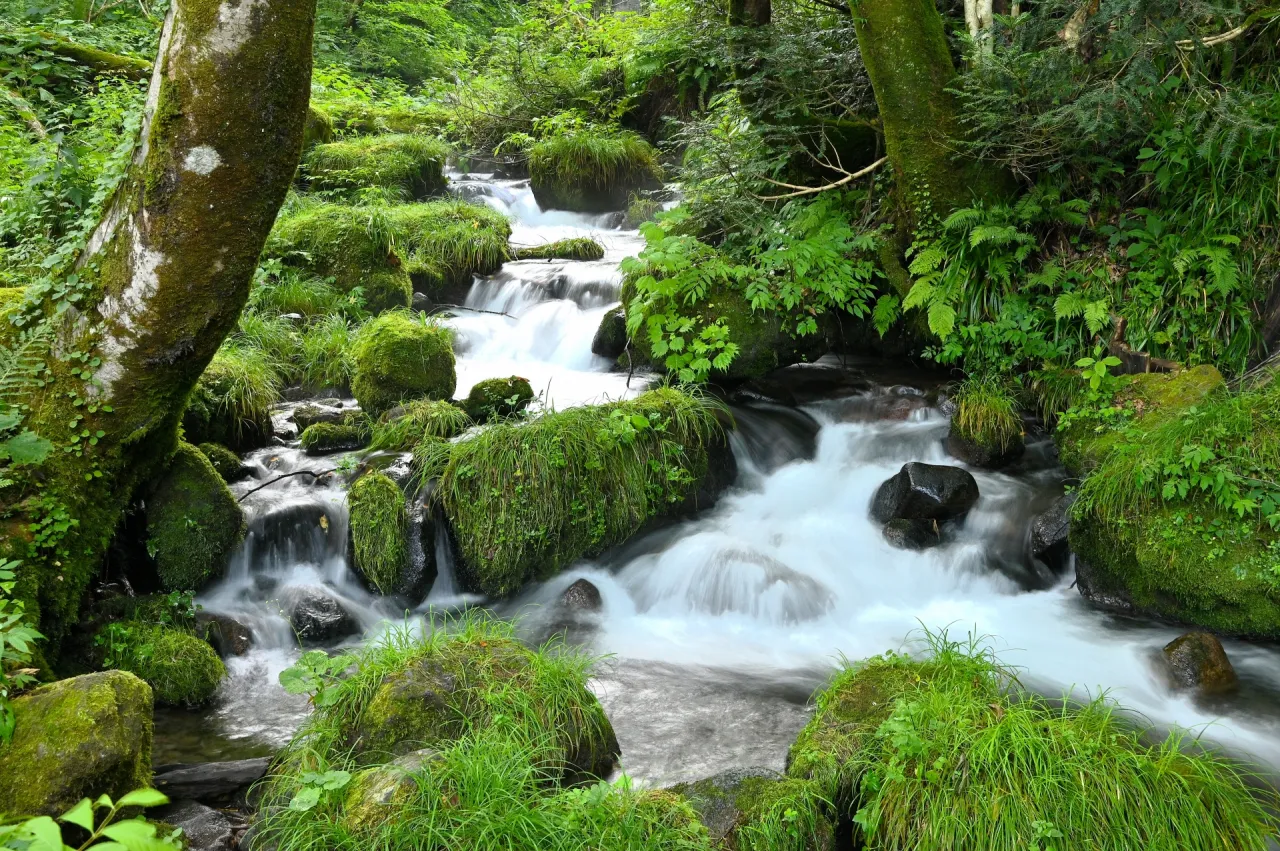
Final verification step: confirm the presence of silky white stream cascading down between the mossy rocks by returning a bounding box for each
[156,175,1280,784]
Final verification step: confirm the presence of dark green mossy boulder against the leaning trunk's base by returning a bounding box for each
[146,443,247,591]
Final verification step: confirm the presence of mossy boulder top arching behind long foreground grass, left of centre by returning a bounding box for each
[346,629,620,783]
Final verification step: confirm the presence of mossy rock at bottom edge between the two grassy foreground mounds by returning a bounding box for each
[671,768,836,851]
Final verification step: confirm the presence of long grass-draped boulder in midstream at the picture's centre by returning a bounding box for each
[430,388,719,596]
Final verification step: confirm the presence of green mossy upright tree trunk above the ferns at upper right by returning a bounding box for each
[854,0,1012,227]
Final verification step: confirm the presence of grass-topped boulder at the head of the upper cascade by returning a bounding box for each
[529,128,662,212]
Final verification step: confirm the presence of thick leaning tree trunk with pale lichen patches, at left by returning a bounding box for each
[0,0,315,653]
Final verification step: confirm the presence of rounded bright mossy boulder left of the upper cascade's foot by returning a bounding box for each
[351,311,457,416]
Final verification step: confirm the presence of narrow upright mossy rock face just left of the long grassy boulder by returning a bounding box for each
[348,470,408,594]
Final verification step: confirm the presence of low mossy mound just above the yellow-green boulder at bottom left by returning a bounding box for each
[101,622,227,706]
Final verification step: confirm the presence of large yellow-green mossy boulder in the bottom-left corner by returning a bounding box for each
[0,671,152,816]
